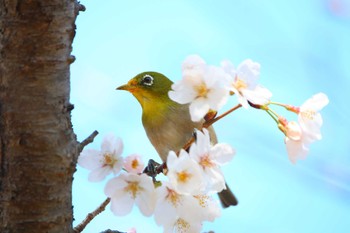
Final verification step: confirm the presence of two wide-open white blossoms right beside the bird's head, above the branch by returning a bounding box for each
[169,55,272,121]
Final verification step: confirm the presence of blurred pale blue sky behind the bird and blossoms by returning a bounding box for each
[71,0,350,233]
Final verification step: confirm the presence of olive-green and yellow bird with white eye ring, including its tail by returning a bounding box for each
[116,71,238,208]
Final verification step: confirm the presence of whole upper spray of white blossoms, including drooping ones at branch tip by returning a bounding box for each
[169,55,329,164]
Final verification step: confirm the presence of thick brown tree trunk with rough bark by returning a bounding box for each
[0,0,80,233]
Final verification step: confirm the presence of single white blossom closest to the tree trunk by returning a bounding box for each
[78,134,123,182]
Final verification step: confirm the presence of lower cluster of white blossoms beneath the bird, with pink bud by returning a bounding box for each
[78,129,235,232]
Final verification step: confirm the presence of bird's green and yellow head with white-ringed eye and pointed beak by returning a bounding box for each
[117,71,173,110]
